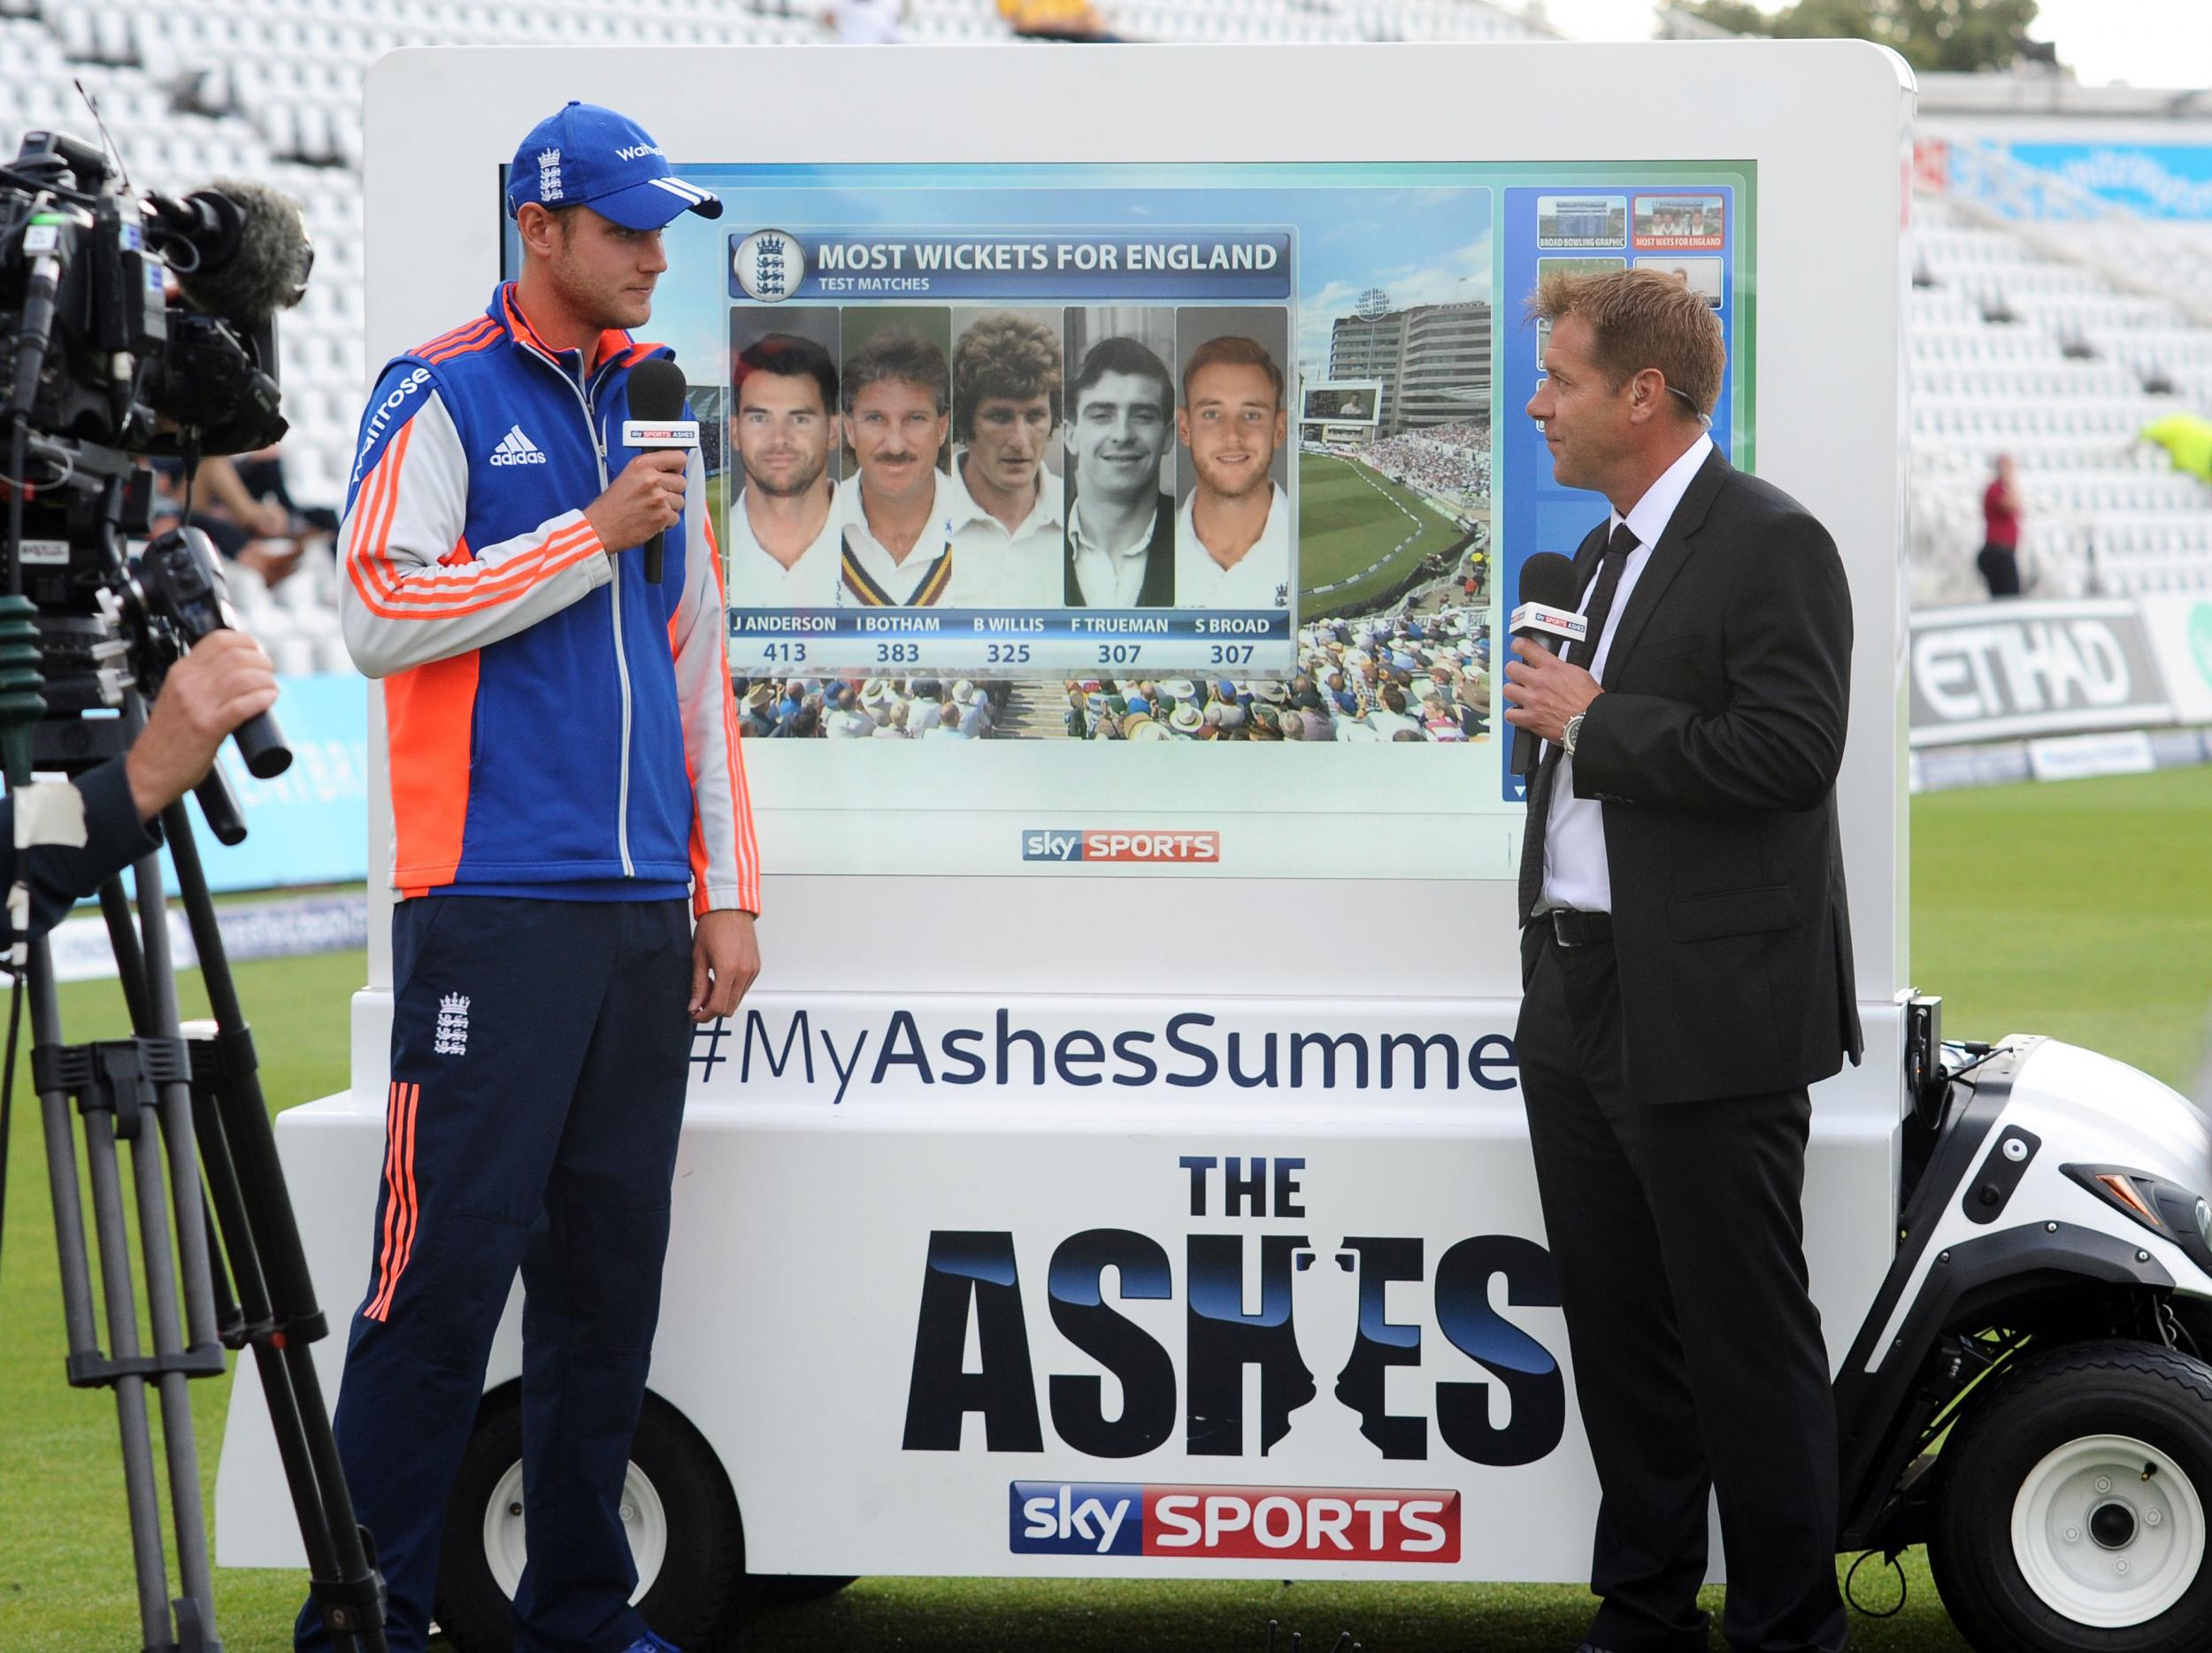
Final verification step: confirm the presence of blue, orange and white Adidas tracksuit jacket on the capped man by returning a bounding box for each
[339,283,761,911]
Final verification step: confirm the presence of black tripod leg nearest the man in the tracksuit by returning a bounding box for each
[162,803,385,1653]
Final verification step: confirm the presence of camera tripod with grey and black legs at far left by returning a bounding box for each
[10,693,385,1653]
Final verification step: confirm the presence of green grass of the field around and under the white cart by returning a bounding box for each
[0,770,2212,1653]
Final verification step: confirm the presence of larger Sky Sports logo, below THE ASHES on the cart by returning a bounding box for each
[1007,1480,1460,1562]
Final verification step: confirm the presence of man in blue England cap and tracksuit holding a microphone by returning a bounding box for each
[296,104,761,1653]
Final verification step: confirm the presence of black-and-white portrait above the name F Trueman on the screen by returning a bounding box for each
[1062,339,1175,609]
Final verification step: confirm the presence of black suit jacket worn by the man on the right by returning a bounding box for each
[1522,451,1865,1102]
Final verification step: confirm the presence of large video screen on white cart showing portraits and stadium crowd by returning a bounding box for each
[553,159,1750,770]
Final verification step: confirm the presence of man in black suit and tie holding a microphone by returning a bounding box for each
[1504,270,1861,1653]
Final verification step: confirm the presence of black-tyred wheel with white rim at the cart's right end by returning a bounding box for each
[1929,1341,2212,1653]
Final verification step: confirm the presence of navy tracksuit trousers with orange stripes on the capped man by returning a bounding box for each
[295,896,690,1653]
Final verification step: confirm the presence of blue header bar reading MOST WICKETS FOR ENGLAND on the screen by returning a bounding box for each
[730,228,1292,304]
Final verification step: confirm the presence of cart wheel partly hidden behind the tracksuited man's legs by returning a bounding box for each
[438,1385,746,1653]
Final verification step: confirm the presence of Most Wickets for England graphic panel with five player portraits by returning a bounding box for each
[728,223,1296,677]
